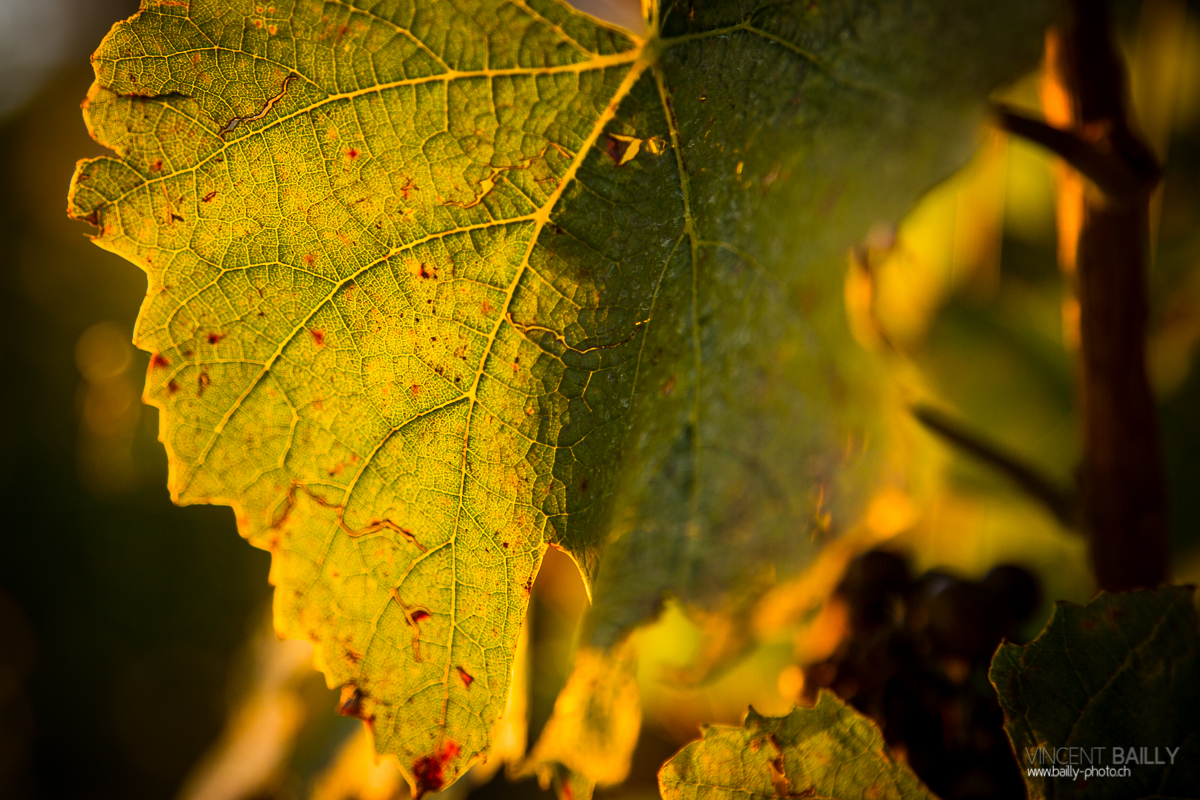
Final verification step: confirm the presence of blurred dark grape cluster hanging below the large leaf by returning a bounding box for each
[804,551,1040,800]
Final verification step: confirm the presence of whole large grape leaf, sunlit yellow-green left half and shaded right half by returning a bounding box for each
[70,0,1048,793]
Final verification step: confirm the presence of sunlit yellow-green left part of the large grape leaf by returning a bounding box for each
[71,1,667,793]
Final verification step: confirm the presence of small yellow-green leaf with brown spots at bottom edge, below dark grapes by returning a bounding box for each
[659,692,935,800]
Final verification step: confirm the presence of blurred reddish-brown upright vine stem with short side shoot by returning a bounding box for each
[997,0,1169,590]
